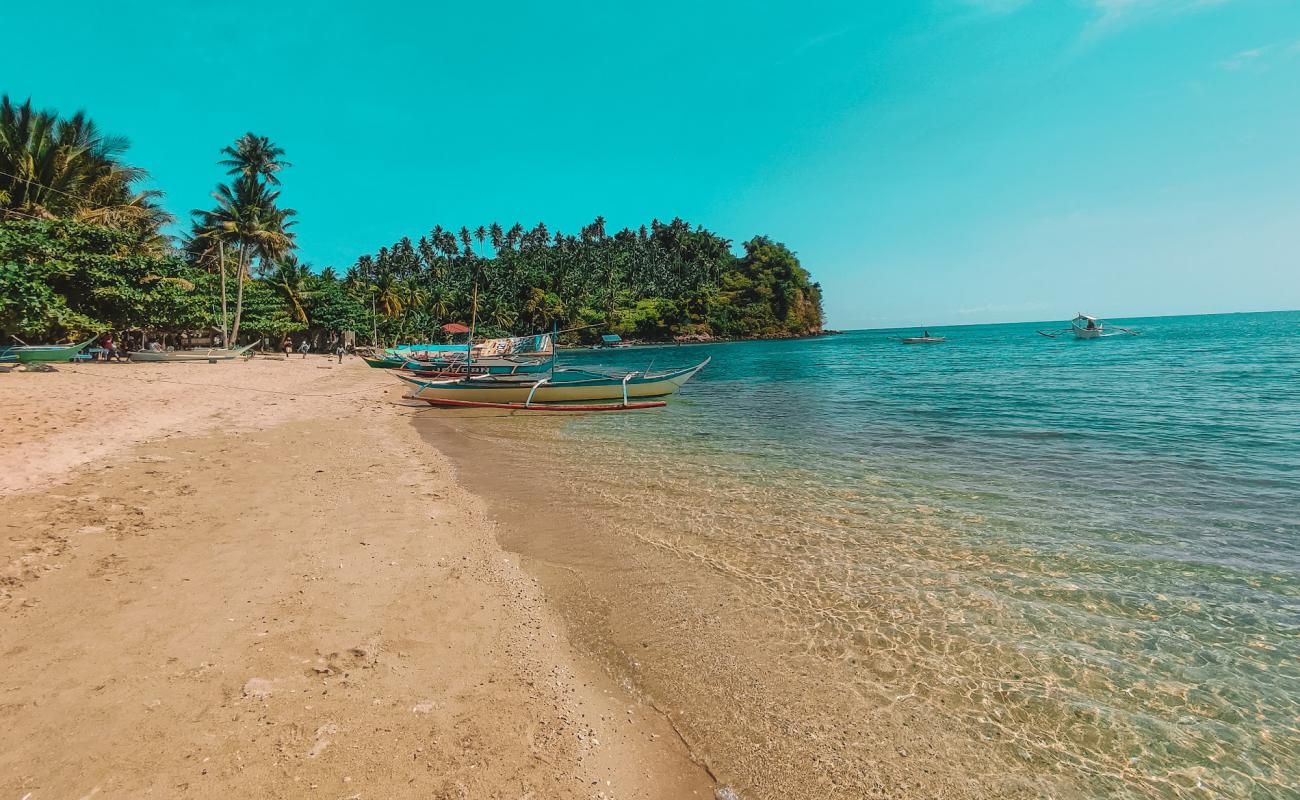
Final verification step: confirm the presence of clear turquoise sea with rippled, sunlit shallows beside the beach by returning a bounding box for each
[452,312,1300,797]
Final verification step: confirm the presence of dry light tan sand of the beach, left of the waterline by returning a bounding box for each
[0,358,714,800]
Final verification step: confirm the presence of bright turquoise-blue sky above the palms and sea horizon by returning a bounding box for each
[0,0,1300,328]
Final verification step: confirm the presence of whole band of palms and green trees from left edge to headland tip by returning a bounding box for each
[0,96,822,343]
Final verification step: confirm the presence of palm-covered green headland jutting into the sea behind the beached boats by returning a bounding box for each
[347,217,822,341]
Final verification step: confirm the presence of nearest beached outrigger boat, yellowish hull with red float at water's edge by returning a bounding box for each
[397,359,710,411]
